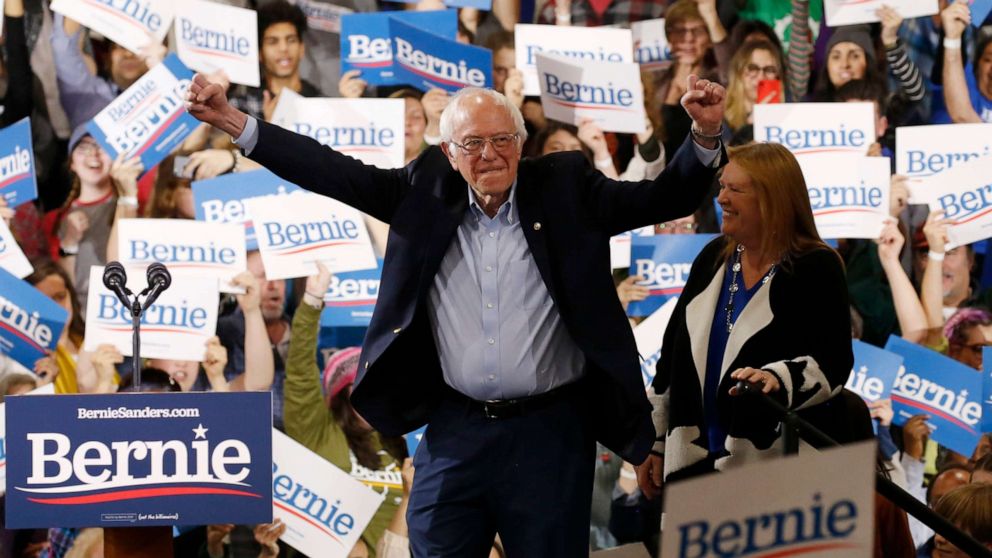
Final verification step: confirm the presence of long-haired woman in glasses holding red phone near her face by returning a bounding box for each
[724,40,785,132]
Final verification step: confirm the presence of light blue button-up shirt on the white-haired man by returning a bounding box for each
[427,183,585,401]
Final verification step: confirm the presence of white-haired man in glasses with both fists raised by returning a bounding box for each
[187,68,725,557]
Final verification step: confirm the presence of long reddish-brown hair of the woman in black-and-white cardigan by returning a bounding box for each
[725,143,830,264]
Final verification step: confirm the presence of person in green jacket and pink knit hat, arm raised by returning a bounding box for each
[283,263,407,556]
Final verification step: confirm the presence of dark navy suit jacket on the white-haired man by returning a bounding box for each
[251,122,725,464]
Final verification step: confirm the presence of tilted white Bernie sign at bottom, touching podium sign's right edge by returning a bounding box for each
[272,428,383,558]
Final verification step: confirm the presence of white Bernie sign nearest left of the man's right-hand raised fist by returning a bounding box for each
[536,54,647,134]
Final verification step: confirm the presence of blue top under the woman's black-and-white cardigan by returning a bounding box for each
[703,263,765,454]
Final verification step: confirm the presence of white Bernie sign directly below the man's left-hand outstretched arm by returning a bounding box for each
[244,194,376,279]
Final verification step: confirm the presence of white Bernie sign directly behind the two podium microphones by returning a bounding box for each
[83,266,220,362]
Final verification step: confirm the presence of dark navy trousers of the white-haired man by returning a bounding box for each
[407,390,595,558]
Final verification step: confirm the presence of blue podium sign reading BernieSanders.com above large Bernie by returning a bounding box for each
[6,392,272,529]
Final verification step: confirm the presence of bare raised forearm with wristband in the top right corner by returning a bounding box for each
[940,0,982,122]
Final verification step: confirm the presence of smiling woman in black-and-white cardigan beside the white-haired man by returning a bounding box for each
[639,143,853,490]
